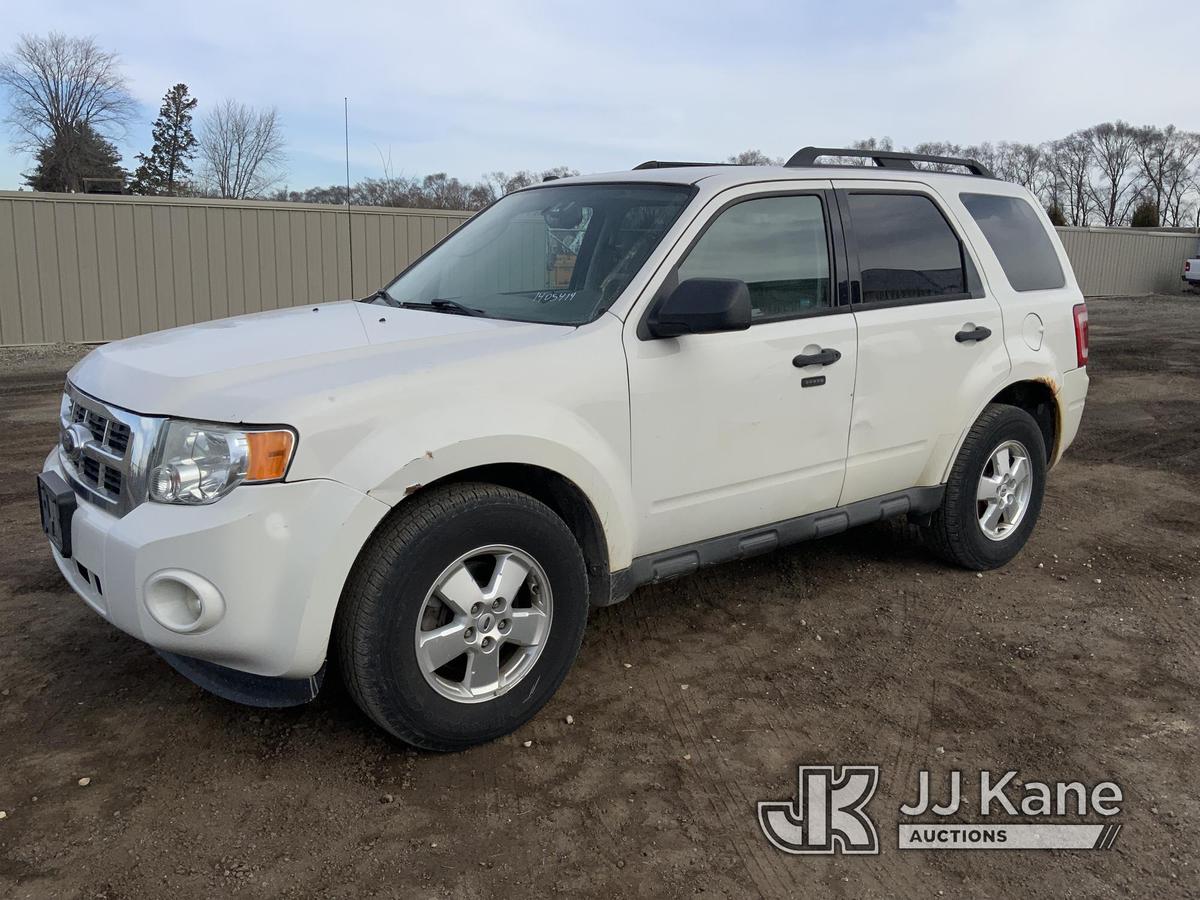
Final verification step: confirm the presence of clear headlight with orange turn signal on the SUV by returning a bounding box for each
[150,419,295,505]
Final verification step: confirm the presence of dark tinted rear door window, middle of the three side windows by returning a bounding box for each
[847,193,968,304]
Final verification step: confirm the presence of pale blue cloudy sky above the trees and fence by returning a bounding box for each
[0,0,1200,188]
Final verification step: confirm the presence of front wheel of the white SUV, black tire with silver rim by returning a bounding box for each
[334,482,588,751]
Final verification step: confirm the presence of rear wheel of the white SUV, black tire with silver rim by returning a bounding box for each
[922,403,1046,571]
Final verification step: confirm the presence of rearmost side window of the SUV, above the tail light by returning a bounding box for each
[959,193,1067,290]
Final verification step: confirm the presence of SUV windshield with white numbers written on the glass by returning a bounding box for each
[374,185,692,325]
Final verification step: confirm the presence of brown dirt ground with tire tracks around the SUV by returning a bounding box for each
[0,298,1200,898]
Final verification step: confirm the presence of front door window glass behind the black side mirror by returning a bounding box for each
[679,194,830,322]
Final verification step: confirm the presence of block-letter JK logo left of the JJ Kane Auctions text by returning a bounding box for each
[758,766,880,853]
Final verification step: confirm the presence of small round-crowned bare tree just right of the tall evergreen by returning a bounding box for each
[200,100,283,200]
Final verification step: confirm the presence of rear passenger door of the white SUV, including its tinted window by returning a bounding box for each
[835,180,1009,504]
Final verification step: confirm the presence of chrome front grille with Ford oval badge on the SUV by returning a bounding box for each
[59,382,162,516]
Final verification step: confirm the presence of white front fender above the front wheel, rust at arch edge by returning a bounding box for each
[286,316,636,569]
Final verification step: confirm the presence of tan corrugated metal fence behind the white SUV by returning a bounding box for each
[0,192,1198,344]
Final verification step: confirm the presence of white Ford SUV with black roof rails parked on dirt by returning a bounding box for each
[40,148,1087,750]
